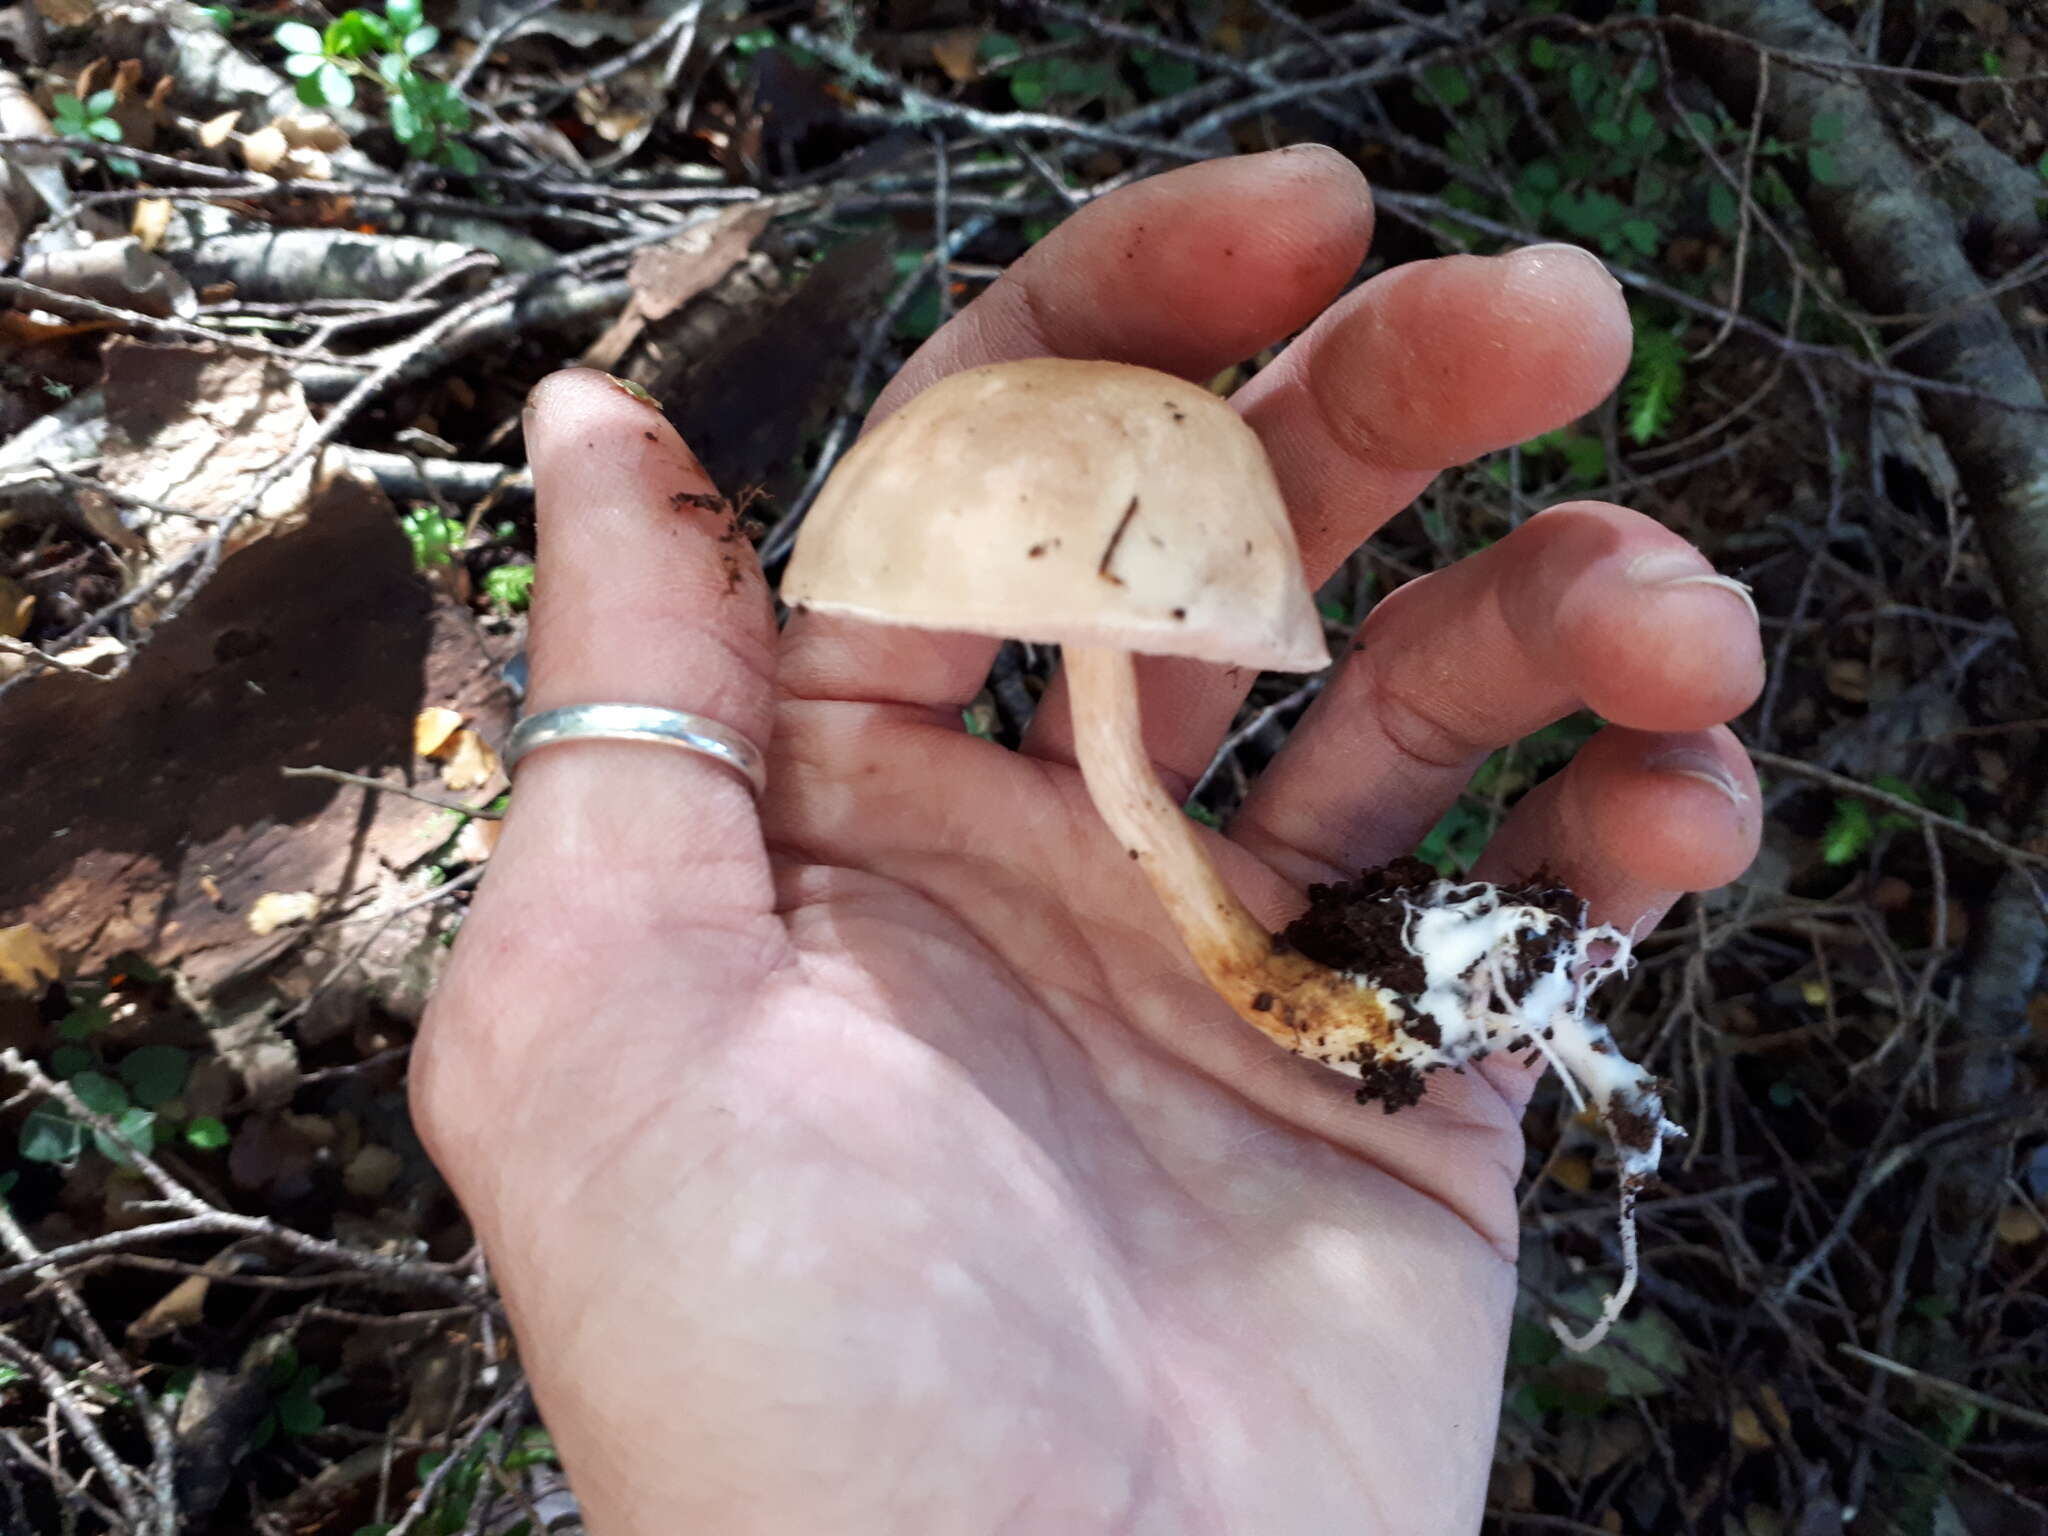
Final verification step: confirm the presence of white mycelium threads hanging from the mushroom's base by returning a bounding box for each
[1358,881,1686,1350]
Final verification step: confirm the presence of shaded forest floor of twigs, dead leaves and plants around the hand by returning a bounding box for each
[0,0,2048,1536]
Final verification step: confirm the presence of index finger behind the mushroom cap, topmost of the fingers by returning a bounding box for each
[782,145,1372,709]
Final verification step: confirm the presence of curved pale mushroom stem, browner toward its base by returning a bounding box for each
[1061,645,1384,1073]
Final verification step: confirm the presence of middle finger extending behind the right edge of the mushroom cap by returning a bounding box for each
[1024,246,1630,782]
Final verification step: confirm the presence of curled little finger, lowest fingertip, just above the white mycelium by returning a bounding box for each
[1473,727,1763,1112]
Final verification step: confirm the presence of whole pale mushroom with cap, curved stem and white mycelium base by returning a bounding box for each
[782,358,1681,1333]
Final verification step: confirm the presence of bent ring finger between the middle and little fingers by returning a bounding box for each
[1231,502,1763,883]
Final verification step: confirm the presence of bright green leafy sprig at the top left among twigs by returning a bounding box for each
[274,0,481,174]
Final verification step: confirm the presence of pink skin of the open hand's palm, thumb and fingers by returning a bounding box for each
[414,150,1759,1536]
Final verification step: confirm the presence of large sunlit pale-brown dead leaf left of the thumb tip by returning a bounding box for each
[100,338,317,573]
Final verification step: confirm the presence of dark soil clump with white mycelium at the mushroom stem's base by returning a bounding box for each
[1282,858,1686,1350]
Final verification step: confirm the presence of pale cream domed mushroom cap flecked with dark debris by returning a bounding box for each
[782,358,1329,672]
